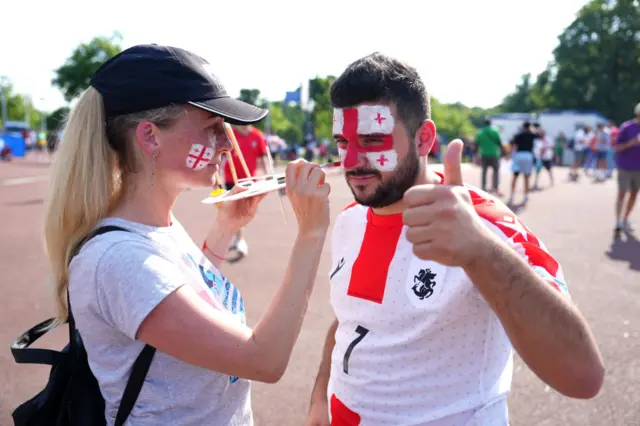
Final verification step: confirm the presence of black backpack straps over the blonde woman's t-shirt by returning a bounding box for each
[70,225,156,426]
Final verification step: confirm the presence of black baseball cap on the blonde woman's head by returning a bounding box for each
[90,44,269,124]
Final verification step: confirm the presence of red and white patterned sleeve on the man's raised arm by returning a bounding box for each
[469,190,569,296]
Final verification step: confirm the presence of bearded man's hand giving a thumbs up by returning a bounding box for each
[403,139,492,267]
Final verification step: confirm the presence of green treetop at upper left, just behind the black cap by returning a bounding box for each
[51,32,122,102]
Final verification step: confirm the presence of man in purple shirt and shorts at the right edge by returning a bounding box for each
[615,103,640,231]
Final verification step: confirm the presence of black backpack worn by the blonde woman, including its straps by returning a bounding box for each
[11,226,155,426]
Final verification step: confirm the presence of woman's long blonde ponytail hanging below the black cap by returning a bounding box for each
[44,87,185,325]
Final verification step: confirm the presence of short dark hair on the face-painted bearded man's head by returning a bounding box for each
[329,52,431,139]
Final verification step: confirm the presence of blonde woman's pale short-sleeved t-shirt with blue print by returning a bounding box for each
[69,218,253,426]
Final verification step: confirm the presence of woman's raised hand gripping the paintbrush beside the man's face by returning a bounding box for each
[285,159,331,236]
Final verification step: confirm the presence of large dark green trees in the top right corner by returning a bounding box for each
[501,0,640,122]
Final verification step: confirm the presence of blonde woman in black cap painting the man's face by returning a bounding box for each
[45,45,330,425]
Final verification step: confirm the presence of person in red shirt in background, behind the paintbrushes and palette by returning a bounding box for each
[224,125,269,262]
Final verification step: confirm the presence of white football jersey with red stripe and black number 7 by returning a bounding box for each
[328,178,568,426]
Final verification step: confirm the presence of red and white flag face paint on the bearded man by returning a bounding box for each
[333,105,398,172]
